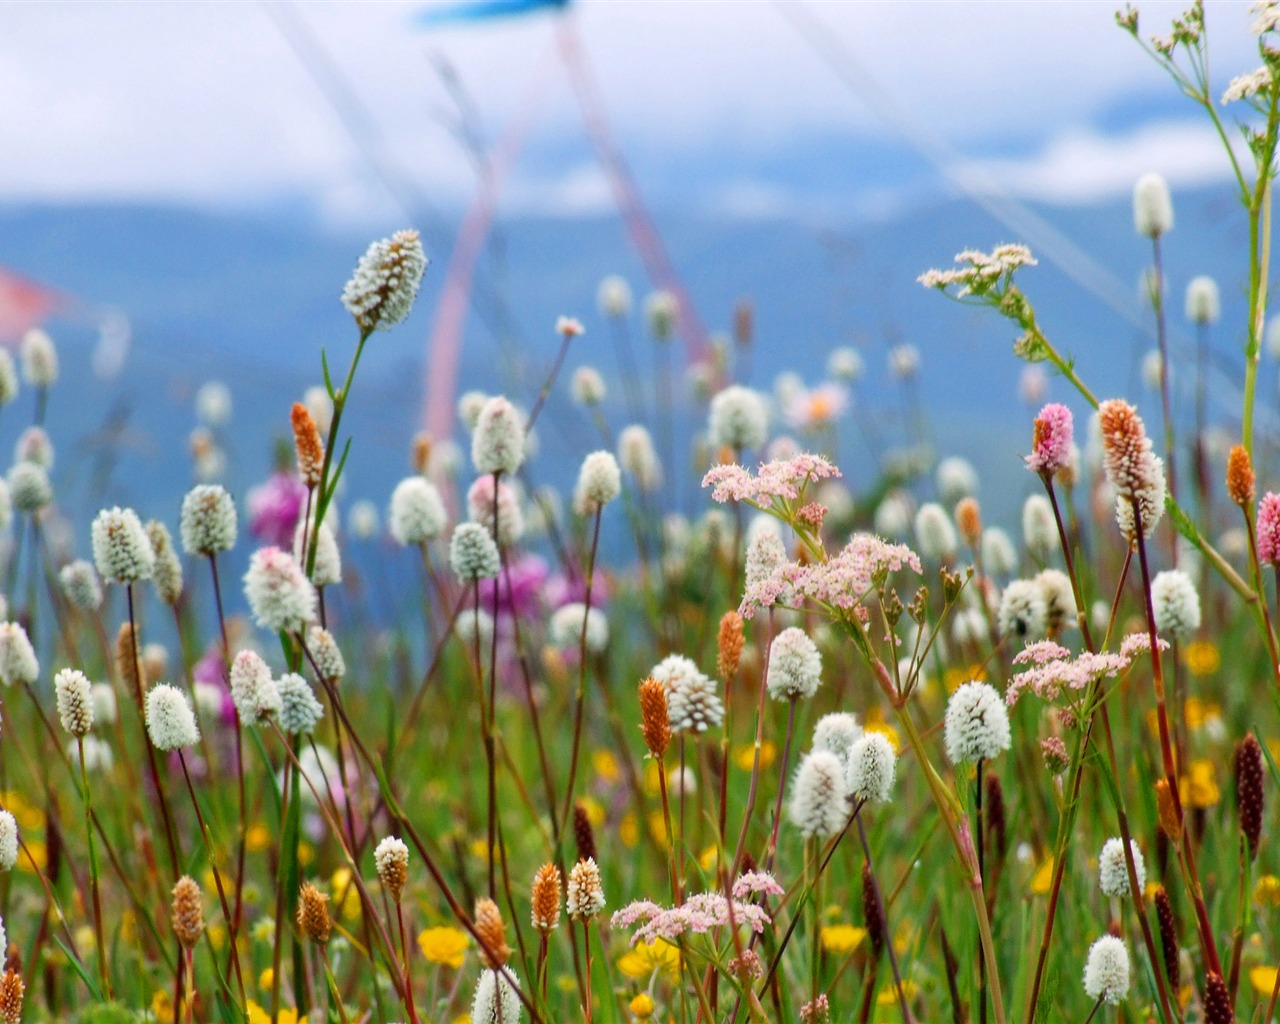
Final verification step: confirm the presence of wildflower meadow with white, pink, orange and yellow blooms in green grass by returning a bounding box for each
[0,3,1280,1024]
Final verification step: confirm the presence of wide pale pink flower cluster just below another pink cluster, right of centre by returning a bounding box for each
[737,534,922,618]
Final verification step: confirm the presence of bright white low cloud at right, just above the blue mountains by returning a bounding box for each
[952,120,1231,204]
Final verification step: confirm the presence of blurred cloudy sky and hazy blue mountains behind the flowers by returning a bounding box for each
[0,0,1276,535]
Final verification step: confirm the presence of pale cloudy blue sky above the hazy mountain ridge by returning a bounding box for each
[0,0,1257,224]
